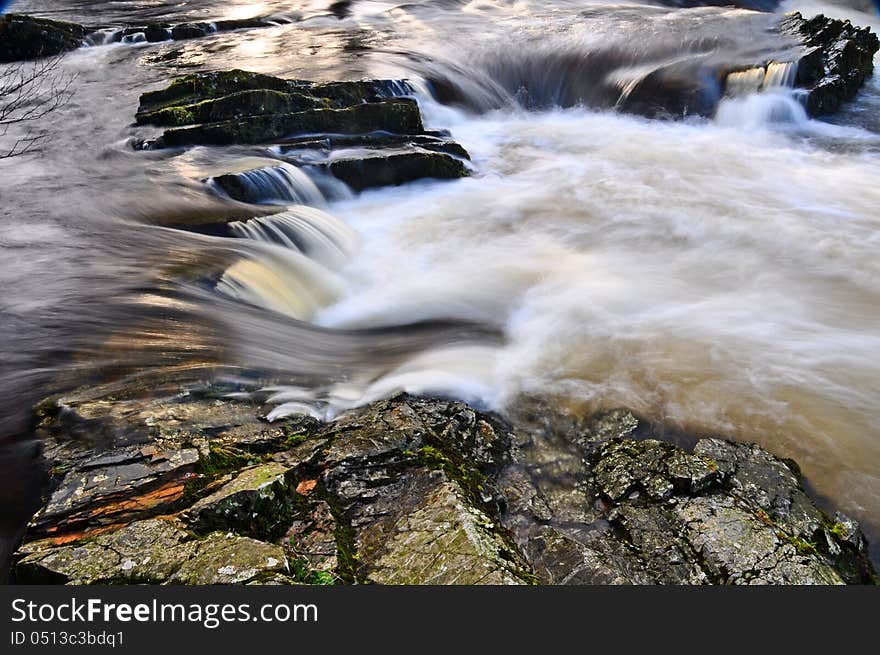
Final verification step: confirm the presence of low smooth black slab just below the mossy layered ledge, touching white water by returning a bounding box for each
[326,151,468,191]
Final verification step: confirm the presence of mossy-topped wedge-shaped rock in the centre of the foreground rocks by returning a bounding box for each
[314,397,532,584]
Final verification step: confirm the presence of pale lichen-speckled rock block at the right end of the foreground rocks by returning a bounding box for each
[593,439,871,584]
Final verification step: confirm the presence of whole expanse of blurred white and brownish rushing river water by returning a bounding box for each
[0,0,880,559]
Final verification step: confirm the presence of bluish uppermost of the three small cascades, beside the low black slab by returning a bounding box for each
[207,163,325,205]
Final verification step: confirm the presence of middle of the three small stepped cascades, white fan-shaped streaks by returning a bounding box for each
[229,206,357,269]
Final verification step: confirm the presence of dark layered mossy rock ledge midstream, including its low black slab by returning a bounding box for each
[135,70,469,196]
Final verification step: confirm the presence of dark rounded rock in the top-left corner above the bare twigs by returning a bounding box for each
[0,14,86,63]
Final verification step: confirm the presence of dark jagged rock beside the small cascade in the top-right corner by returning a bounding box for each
[780,12,880,116]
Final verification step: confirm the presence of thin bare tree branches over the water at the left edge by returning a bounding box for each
[0,55,76,159]
